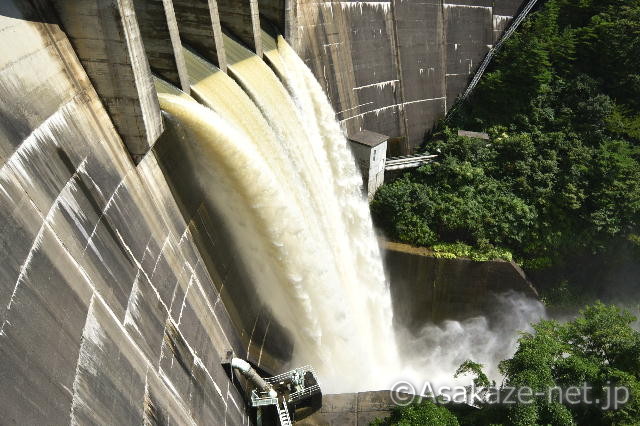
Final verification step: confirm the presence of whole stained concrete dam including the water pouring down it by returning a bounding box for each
[0,0,519,424]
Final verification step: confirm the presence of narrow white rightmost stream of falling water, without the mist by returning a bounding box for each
[278,37,399,366]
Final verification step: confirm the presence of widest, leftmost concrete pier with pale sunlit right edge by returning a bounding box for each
[50,0,163,158]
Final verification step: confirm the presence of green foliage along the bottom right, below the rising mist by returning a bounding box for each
[375,303,640,426]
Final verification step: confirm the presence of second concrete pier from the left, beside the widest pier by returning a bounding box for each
[133,0,190,93]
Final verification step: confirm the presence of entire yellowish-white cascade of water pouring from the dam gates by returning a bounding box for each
[160,38,398,392]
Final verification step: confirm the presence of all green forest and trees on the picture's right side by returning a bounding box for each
[371,0,640,425]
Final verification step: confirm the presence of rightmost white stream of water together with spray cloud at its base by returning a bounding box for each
[265,37,546,392]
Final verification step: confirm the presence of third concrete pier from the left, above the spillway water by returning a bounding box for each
[173,0,227,72]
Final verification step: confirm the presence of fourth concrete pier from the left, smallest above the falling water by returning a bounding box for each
[218,0,262,57]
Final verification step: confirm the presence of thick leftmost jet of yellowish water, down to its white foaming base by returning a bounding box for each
[160,90,395,392]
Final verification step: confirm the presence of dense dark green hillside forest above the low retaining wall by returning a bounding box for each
[372,0,640,266]
